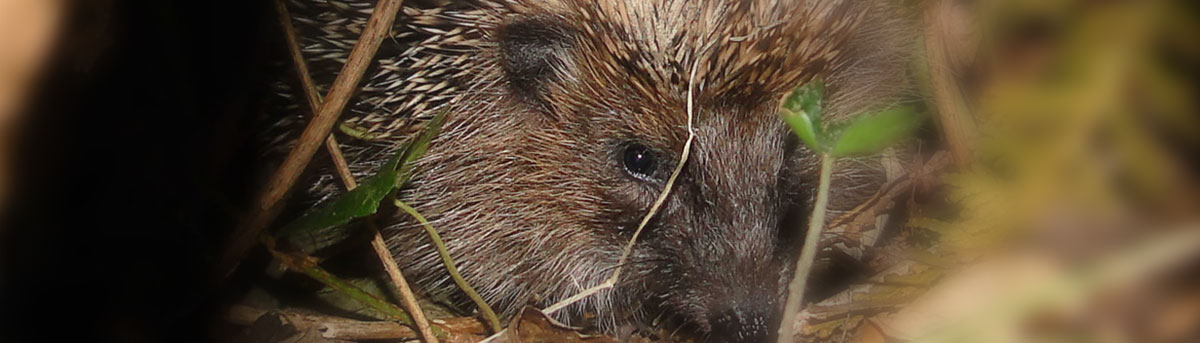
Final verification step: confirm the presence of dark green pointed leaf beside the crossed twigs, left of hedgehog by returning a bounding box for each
[277,112,446,253]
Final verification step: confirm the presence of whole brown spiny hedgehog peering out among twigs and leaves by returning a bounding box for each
[264,0,912,342]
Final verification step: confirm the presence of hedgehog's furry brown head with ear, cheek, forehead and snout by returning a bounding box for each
[388,0,902,342]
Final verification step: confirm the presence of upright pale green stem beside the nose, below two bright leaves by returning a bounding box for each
[776,154,833,343]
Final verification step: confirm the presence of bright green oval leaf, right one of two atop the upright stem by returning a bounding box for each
[833,107,920,157]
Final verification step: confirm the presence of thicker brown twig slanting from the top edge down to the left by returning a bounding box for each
[218,0,402,275]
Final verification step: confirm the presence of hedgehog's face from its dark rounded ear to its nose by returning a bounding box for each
[453,4,849,342]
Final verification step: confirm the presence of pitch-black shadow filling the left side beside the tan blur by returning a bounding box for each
[0,0,282,342]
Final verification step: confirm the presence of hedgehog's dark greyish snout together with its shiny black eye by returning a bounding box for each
[598,108,808,342]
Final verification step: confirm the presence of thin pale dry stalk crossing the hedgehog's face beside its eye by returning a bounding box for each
[541,47,700,315]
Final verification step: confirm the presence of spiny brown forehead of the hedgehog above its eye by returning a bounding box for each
[518,0,865,146]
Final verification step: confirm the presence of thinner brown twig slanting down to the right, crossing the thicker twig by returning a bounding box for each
[275,0,438,343]
